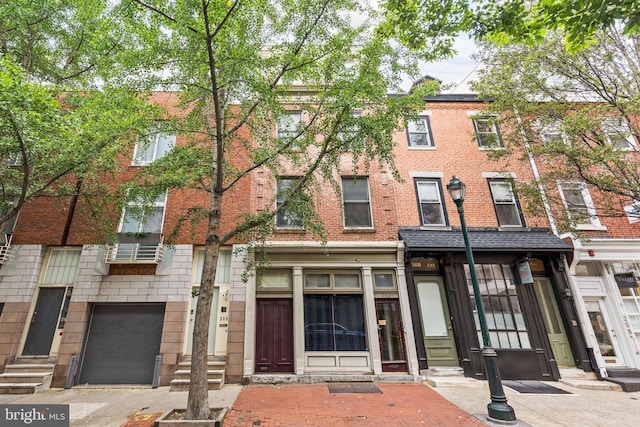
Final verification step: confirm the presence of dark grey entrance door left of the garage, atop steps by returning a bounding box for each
[22,286,71,356]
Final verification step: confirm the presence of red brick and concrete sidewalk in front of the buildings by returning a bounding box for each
[0,380,640,427]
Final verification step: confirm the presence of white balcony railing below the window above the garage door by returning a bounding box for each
[105,233,164,264]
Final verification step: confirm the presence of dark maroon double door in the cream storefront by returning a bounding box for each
[256,298,293,373]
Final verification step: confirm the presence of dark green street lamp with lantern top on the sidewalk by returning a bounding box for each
[447,176,517,424]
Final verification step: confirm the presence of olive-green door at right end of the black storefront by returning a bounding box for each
[533,277,575,367]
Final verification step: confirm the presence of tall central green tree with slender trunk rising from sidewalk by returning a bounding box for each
[114,0,433,419]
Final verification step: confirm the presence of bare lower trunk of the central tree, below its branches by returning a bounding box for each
[185,193,222,420]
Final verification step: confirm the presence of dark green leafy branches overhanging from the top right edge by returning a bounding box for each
[379,0,640,54]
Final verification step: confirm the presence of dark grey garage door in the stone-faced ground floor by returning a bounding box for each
[78,304,164,384]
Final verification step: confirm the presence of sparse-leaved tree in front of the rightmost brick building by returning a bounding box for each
[473,26,640,230]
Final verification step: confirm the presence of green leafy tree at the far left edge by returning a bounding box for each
[0,0,157,234]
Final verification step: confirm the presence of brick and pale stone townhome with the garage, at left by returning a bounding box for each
[0,93,249,387]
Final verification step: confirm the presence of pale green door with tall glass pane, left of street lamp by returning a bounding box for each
[416,277,460,366]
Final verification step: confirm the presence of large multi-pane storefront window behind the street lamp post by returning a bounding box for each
[464,264,531,349]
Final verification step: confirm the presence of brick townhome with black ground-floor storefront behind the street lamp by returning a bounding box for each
[394,89,592,380]
